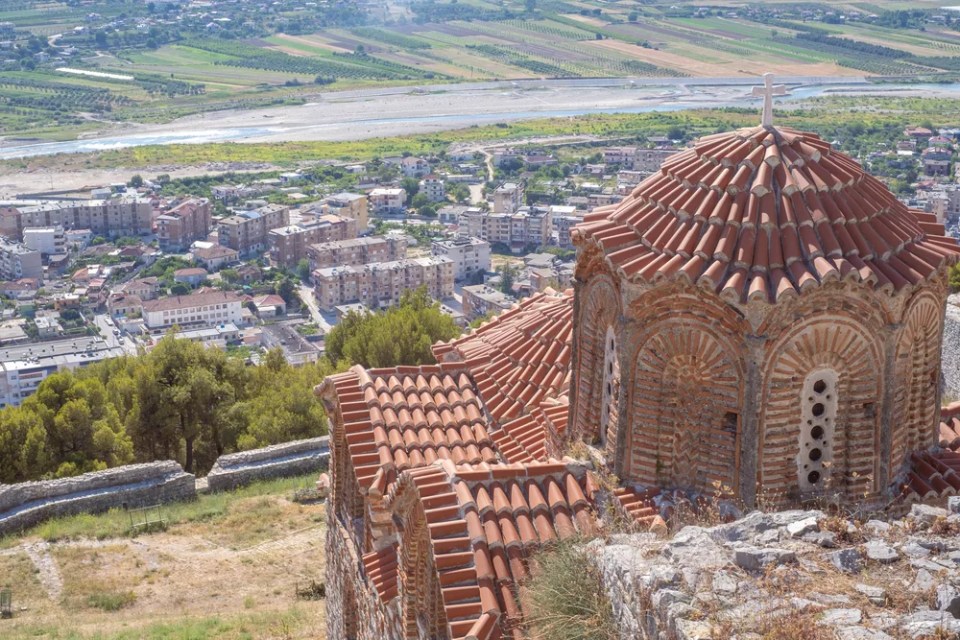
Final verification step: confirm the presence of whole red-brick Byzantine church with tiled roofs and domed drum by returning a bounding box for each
[317,107,960,639]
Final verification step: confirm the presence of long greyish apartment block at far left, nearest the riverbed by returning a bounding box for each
[13,197,153,239]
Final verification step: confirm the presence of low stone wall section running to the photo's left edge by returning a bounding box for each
[0,460,197,534]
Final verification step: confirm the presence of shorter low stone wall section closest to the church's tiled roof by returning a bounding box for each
[207,436,330,491]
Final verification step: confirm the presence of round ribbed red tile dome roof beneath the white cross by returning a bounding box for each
[573,127,958,302]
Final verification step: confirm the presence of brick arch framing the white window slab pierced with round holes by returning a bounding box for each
[757,311,883,502]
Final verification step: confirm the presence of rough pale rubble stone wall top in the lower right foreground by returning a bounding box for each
[588,497,960,640]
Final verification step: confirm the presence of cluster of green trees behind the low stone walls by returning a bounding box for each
[0,288,460,483]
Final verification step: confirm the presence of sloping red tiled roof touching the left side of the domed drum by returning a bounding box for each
[433,291,573,423]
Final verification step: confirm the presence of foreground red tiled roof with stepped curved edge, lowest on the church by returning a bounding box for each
[387,461,598,638]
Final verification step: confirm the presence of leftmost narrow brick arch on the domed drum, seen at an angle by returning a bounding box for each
[571,273,621,444]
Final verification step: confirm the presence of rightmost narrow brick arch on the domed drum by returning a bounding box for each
[890,291,943,472]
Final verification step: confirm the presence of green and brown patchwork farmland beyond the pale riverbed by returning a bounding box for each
[0,0,960,139]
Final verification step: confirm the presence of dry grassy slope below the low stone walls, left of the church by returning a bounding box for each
[0,475,325,640]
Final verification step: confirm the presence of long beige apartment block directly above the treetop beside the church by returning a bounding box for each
[313,257,454,311]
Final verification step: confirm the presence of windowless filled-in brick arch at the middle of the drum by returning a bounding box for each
[623,312,744,493]
